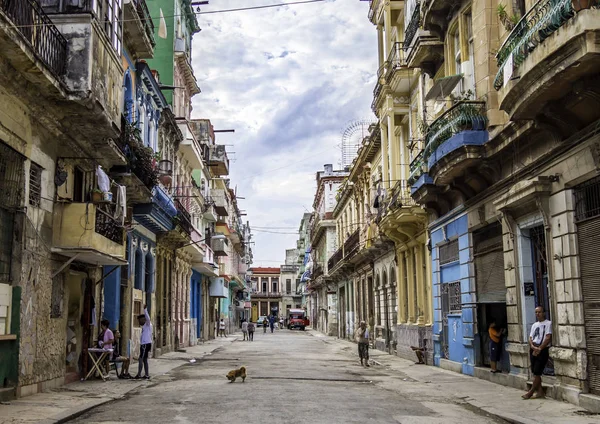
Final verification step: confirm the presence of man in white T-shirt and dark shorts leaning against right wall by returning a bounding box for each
[521,306,552,399]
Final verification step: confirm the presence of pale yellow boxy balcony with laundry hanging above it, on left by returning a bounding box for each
[52,203,127,266]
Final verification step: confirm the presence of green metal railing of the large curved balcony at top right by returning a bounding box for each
[494,0,575,90]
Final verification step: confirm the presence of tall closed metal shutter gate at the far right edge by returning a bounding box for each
[575,177,600,395]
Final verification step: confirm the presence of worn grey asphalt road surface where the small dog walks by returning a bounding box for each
[72,328,504,424]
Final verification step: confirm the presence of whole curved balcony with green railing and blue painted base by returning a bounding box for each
[423,101,488,179]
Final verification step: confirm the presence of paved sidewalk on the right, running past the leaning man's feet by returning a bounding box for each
[310,330,600,424]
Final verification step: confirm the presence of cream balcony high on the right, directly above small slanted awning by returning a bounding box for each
[404,2,444,78]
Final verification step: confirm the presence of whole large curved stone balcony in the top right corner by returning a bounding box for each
[494,0,600,124]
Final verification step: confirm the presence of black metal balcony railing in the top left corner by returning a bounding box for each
[0,0,67,78]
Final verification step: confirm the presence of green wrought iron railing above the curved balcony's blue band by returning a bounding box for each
[424,100,488,160]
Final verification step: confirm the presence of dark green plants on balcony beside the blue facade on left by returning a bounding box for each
[120,119,158,189]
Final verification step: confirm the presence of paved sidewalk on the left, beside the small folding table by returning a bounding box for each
[0,334,239,424]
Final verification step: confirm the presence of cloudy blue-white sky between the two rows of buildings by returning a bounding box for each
[192,0,377,266]
